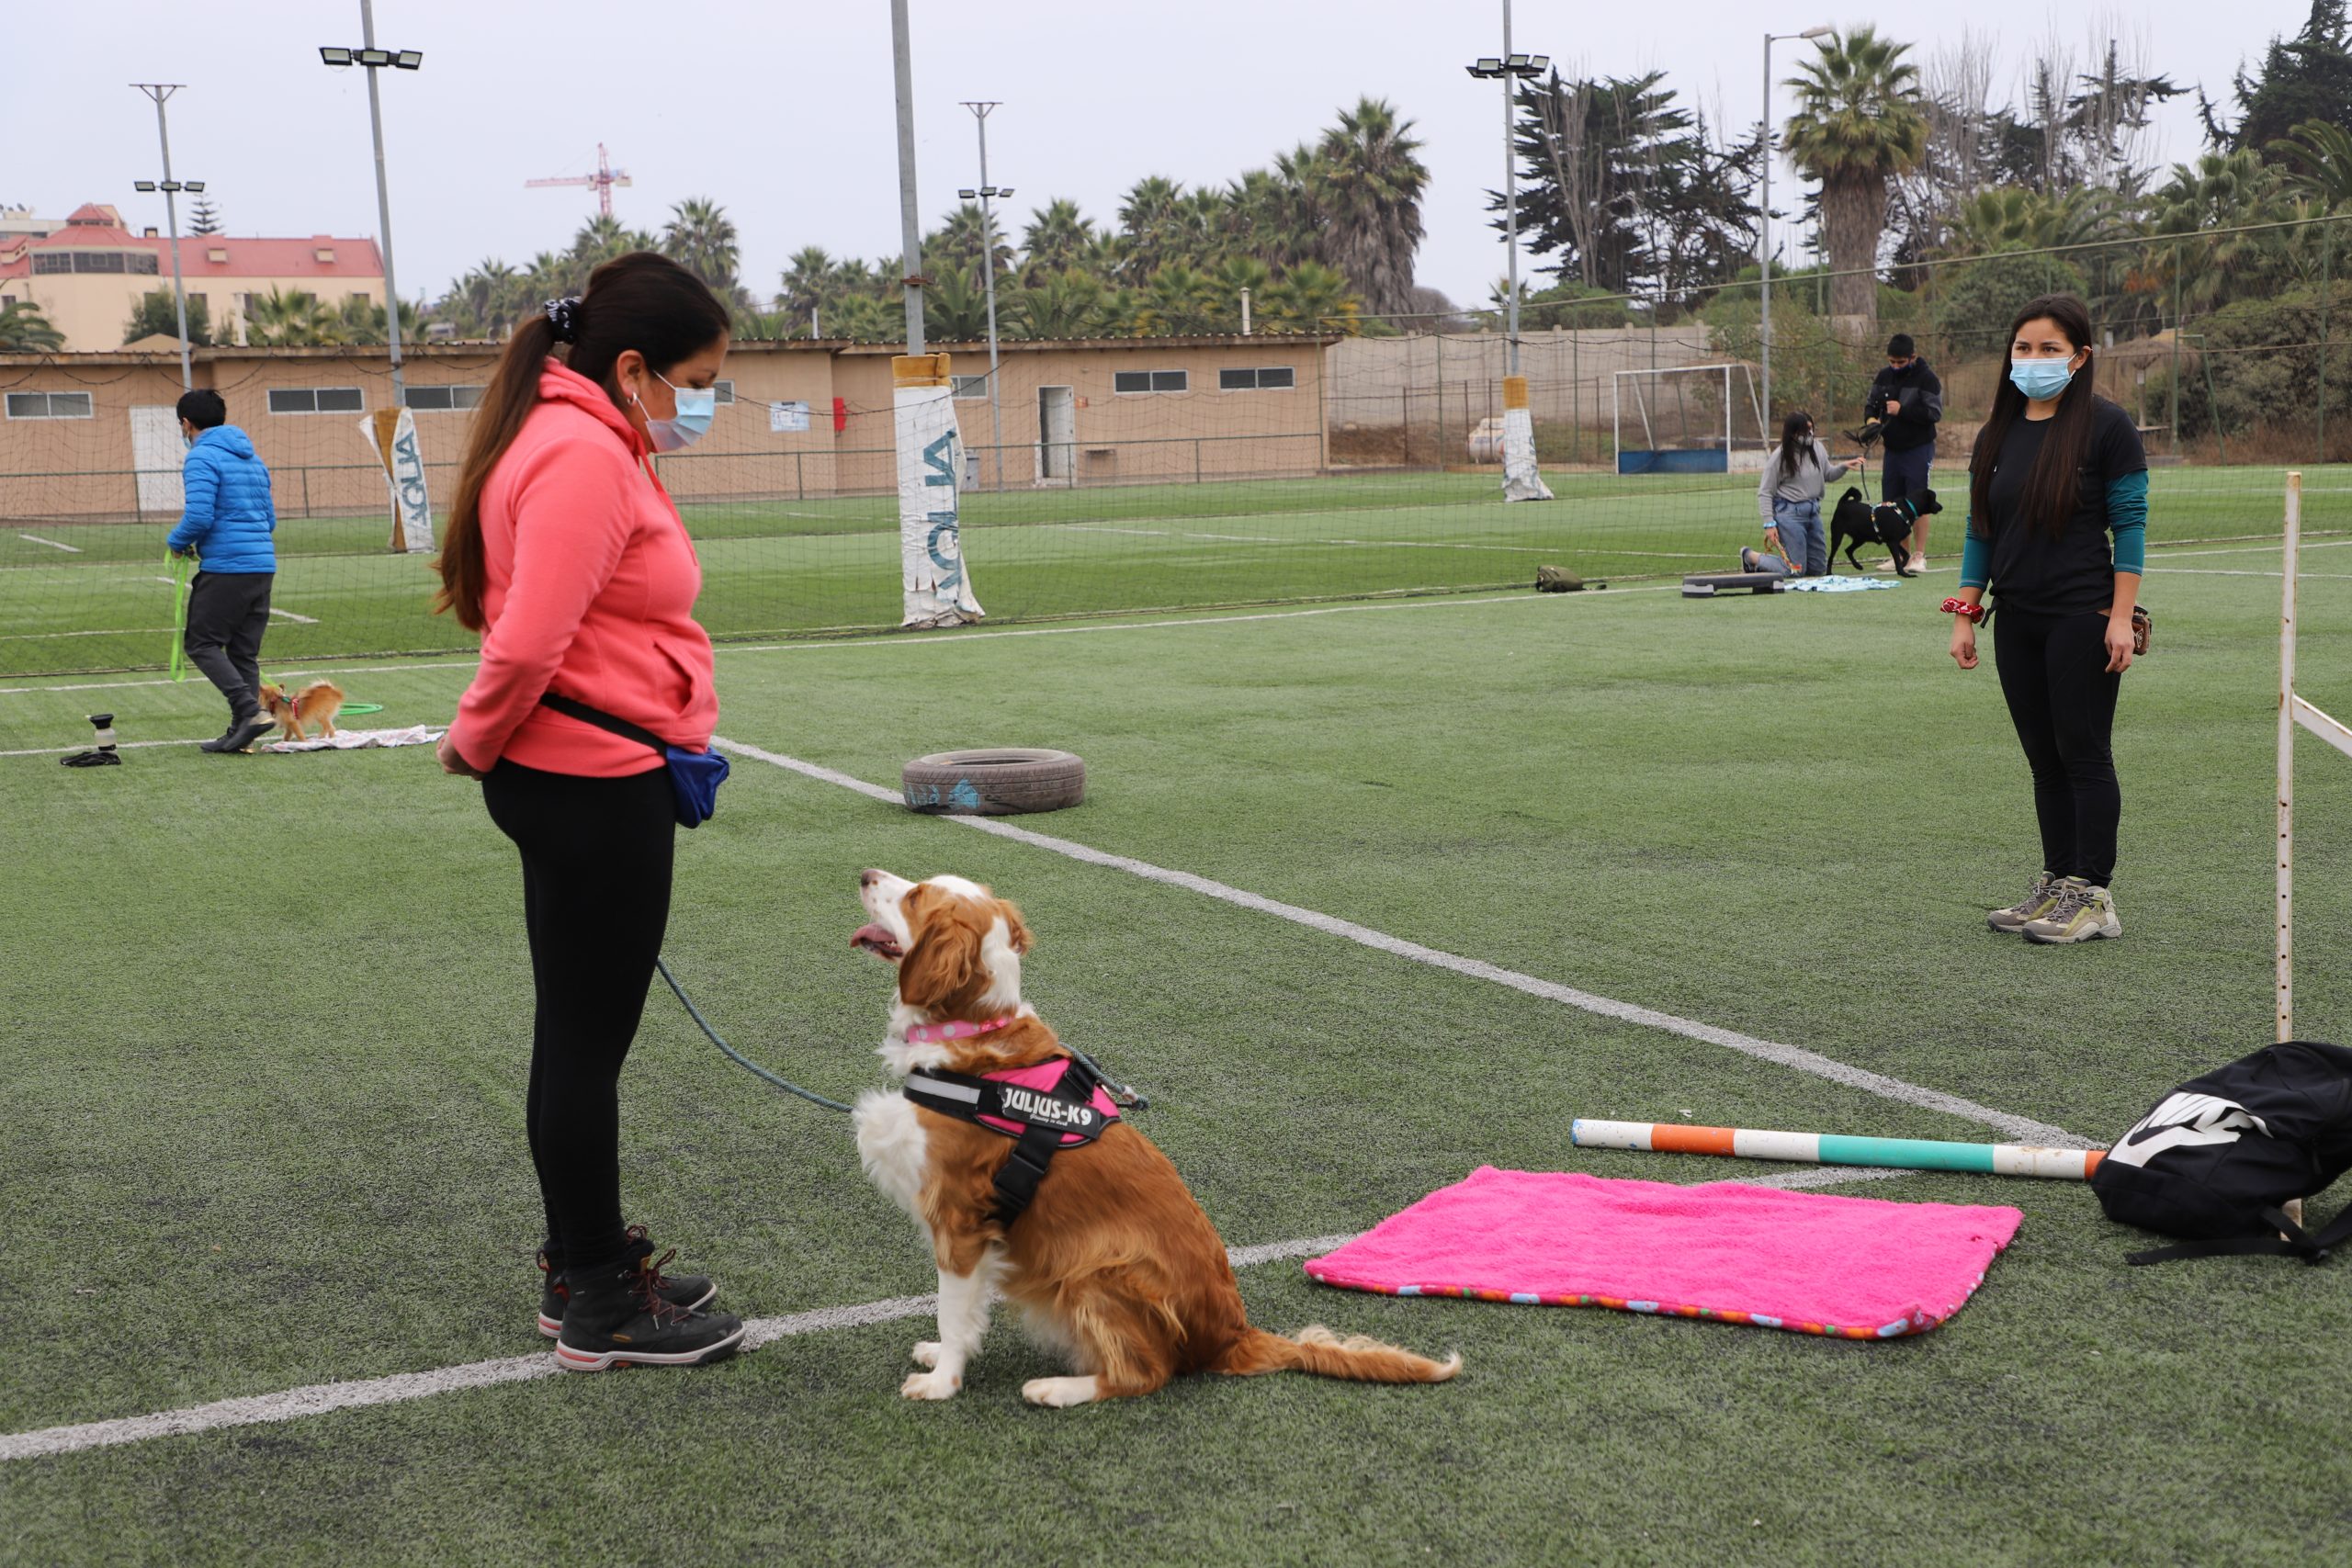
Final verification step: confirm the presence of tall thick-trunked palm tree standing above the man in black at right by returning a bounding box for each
[1782,26,1927,333]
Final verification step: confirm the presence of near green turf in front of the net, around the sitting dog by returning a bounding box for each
[0,501,2352,1563]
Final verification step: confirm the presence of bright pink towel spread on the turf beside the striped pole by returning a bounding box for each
[1306,1166,2025,1340]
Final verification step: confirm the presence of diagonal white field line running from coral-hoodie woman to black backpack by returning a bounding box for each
[710,736,2091,1149]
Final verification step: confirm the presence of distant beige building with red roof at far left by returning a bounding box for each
[0,205,383,353]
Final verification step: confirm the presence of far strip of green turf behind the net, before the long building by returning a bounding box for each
[0,468,2352,682]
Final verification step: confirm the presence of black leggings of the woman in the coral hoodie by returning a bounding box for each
[482,761,677,1267]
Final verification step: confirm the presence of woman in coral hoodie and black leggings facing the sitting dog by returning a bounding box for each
[437,252,743,1371]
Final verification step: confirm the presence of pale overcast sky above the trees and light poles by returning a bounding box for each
[0,0,2310,312]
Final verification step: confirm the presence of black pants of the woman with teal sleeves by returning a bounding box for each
[1992,609,2124,886]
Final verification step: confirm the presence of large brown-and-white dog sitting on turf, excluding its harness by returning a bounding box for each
[852,870,1461,1405]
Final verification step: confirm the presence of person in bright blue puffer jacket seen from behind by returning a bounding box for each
[164,388,277,752]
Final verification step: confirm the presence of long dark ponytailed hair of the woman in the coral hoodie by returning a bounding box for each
[433,252,729,632]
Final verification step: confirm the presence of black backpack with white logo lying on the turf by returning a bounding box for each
[2091,1039,2352,1262]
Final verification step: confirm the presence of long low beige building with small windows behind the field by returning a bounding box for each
[0,336,1334,522]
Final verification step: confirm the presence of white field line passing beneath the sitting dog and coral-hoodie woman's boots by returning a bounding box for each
[0,1166,1917,1464]
